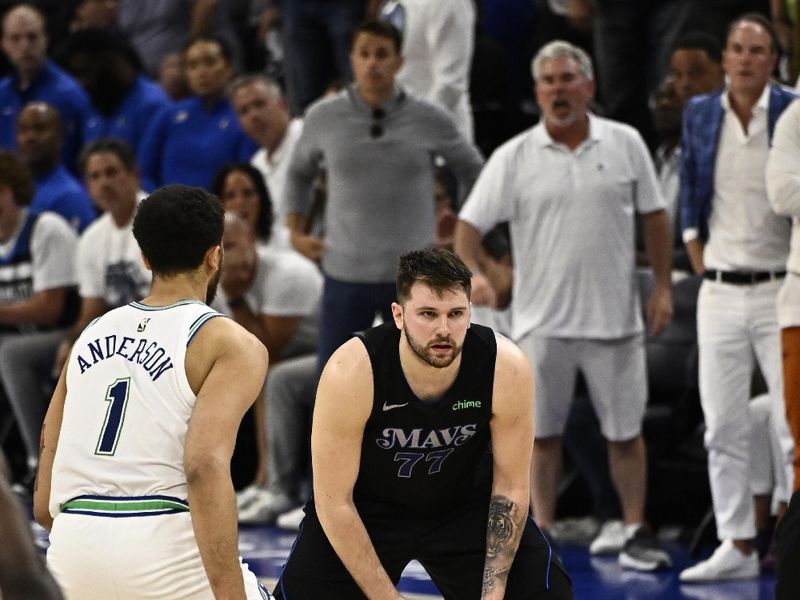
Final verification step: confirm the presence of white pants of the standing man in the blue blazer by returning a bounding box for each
[697,281,794,540]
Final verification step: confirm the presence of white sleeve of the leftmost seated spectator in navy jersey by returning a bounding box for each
[31,213,78,293]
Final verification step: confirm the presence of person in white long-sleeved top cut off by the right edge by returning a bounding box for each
[767,72,800,600]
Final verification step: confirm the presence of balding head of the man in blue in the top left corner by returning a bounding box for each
[1,4,47,79]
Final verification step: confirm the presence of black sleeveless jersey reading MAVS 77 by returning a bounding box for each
[353,323,497,516]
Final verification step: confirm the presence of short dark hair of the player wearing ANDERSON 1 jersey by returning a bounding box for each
[133,185,224,276]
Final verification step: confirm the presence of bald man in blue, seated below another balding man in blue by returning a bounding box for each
[17,102,96,233]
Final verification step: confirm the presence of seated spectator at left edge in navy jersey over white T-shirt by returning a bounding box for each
[0,151,78,491]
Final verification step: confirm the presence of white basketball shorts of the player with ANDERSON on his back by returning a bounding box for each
[47,512,269,600]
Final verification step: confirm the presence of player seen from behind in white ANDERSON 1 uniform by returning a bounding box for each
[34,185,269,600]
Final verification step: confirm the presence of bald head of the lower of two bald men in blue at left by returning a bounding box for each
[16,102,61,175]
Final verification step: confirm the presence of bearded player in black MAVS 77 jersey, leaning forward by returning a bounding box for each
[275,250,573,600]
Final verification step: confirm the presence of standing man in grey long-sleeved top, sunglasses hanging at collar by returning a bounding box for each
[285,21,483,372]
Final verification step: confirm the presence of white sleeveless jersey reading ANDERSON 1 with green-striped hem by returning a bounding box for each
[50,301,220,516]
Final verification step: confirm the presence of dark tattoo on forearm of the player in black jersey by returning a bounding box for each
[483,496,527,594]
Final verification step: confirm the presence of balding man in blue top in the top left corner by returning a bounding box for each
[0,4,90,170]
